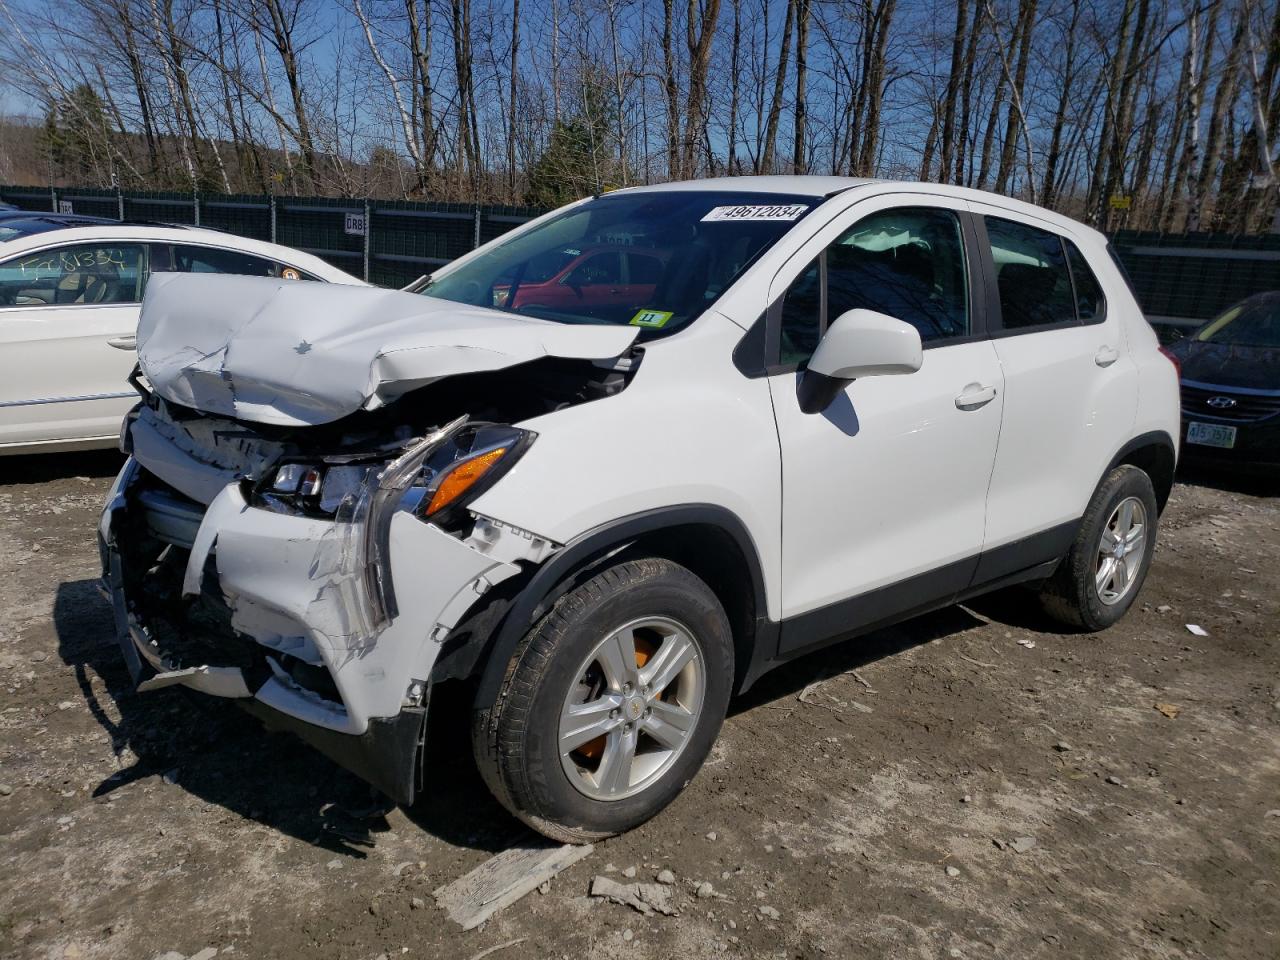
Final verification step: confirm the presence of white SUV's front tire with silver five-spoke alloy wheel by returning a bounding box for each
[472,558,733,844]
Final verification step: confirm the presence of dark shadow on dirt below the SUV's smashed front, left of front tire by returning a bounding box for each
[54,580,520,859]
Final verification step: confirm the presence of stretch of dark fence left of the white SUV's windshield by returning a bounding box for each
[0,187,543,287]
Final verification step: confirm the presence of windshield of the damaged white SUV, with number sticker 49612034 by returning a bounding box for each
[421,191,818,335]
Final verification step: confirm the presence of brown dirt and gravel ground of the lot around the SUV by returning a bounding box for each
[0,454,1280,960]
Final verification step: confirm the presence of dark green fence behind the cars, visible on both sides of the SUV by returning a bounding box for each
[0,187,1280,328]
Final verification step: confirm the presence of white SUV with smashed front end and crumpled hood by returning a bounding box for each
[100,177,1179,841]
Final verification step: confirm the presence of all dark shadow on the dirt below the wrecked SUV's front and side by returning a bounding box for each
[54,580,1052,859]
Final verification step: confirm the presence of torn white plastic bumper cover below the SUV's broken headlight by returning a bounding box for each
[176,485,518,733]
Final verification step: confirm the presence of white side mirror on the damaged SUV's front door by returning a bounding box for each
[799,310,924,413]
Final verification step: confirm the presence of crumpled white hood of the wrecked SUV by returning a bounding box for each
[138,273,639,426]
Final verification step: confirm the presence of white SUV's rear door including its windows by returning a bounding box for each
[970,204,1138,568]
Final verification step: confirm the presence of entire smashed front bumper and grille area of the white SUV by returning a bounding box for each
[110,403,535,733]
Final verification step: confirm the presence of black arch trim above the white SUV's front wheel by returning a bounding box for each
[475,503,777,704]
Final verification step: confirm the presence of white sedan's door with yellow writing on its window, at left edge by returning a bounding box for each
[0,241,146,445]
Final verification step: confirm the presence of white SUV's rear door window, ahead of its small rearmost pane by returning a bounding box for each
[984,216,1076,330]
